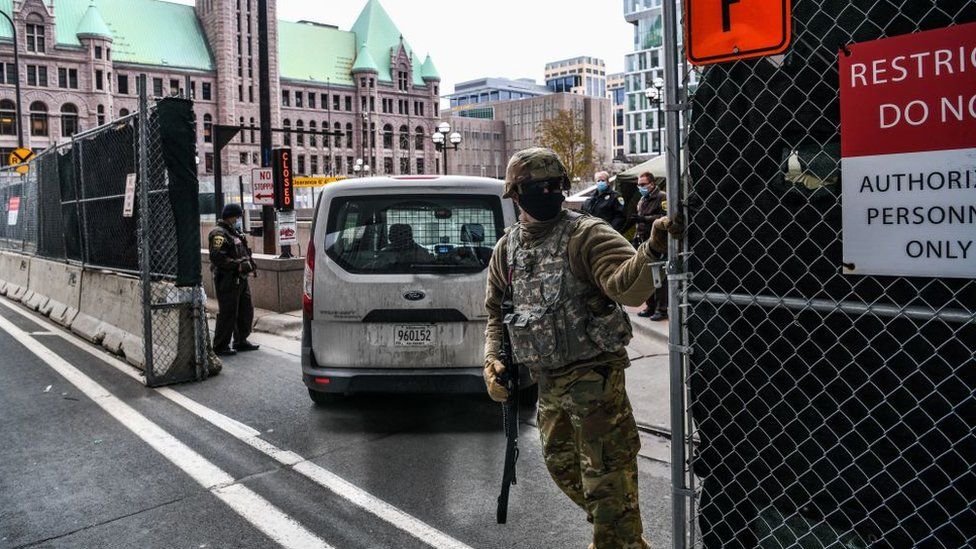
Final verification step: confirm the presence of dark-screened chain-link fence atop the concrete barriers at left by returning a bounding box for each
[0,79,216,386]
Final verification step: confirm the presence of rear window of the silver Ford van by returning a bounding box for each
[325,195,504,274]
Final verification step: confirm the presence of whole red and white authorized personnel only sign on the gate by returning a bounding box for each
[839,23,976,277]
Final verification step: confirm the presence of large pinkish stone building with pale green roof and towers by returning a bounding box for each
[0,0,440,174]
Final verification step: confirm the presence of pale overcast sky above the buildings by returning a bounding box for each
[181,0,633,93]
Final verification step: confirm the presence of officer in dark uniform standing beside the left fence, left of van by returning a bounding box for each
[208,204,259,356]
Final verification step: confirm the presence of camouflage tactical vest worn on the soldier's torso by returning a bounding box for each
[504,212,633,374]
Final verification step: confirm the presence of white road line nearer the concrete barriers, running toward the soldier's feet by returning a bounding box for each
[0,300,473,549]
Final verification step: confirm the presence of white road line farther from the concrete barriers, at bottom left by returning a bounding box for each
[0,317,332,549]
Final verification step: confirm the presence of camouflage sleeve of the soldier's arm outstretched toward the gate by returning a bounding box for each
[569,220,654,307]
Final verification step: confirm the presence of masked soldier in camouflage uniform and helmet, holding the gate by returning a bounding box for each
[484,148,667,549]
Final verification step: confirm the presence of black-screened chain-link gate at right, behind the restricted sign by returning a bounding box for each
[664,0,976,547]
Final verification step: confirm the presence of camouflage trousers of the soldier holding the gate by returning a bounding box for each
[539,368,649,549]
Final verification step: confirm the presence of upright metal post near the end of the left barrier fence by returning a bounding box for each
[137,74,154,386]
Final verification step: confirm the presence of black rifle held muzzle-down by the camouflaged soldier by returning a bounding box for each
[495,286,519,524]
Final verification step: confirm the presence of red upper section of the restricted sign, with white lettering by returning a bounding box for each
[840,23,976,158]
